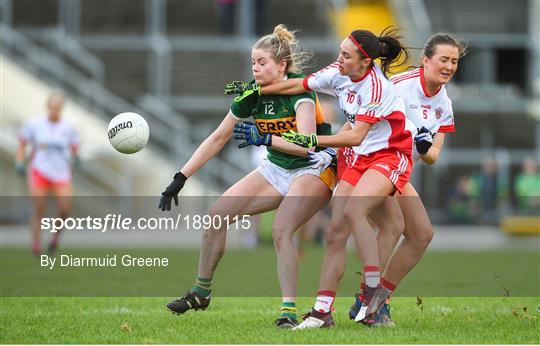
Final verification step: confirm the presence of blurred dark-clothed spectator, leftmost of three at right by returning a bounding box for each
[448,175,477,224]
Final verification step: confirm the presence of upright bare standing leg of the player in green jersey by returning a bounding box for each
[272,174,332,297]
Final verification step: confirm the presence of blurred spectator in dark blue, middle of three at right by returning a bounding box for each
[471,159,508,224]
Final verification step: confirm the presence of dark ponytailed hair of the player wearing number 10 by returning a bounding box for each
[351,27,409,75]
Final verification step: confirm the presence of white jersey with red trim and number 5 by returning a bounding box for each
[390,68,455,133]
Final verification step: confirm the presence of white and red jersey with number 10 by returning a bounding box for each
[304,62,414,155]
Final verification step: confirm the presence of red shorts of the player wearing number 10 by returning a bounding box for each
[337,148,413,193]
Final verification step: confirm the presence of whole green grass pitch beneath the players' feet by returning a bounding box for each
[0,247,540,344]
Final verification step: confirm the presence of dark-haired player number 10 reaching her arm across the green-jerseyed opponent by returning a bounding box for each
[226,30,414,329]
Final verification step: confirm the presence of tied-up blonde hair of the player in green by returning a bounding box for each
[253,24,313,73]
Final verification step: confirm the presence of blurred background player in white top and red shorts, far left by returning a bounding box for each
[16,92,79,256]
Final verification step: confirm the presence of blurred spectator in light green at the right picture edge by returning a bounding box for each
[514,157,540,214]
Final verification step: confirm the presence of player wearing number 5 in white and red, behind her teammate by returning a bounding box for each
[349,34,465,325]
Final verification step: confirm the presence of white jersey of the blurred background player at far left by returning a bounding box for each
[19,116,79,182]
